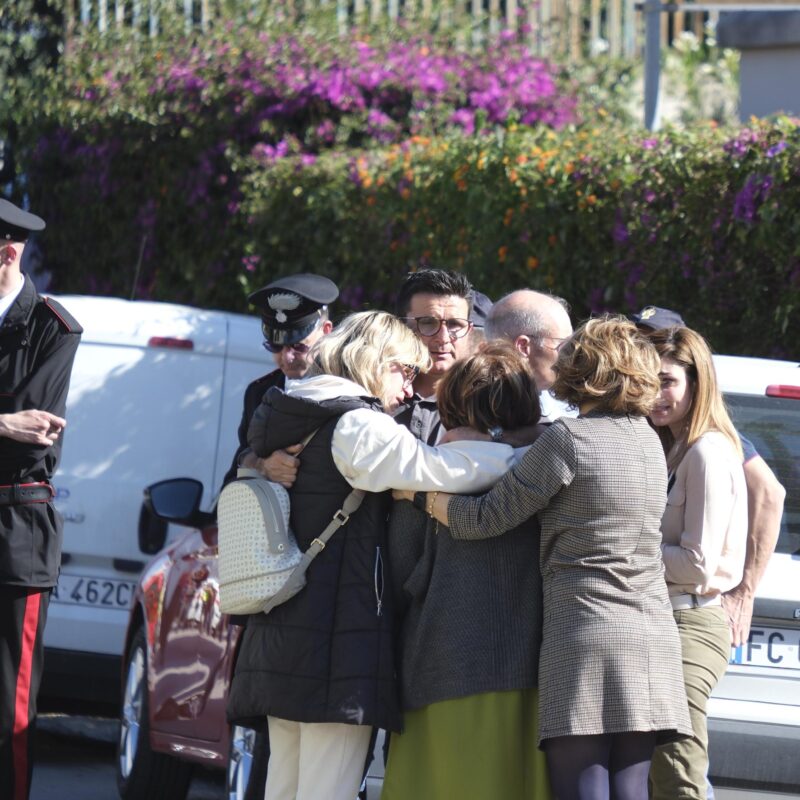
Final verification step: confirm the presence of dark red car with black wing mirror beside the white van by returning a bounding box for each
[117,478,269,800]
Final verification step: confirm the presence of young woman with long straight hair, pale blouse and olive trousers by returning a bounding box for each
[650,328,747,800]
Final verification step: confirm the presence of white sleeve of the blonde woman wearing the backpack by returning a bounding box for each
[331,408,515,493]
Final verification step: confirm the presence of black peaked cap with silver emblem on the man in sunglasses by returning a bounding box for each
[248,272,339,346]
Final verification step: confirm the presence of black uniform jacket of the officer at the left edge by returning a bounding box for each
[0,276,83,587]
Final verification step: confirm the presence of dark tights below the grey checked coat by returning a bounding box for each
[545,732,656,800]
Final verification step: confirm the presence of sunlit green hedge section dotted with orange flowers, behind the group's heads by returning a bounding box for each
[233,120,800,358]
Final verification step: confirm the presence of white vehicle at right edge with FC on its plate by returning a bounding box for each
[708,356,800,793]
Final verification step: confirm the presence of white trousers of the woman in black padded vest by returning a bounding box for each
[264,717,372,800]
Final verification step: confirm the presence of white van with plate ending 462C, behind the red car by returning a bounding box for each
[42,296,274,702]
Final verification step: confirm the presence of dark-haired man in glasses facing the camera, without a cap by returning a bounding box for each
[395,269,478,445]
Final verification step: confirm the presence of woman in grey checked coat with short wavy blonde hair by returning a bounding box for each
[400,317,691,800]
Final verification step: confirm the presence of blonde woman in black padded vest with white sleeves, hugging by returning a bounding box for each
[228,311,513,800]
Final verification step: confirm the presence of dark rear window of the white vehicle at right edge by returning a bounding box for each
[725,394,800,555]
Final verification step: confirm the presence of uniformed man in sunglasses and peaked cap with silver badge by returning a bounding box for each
[225,273,339,488]
